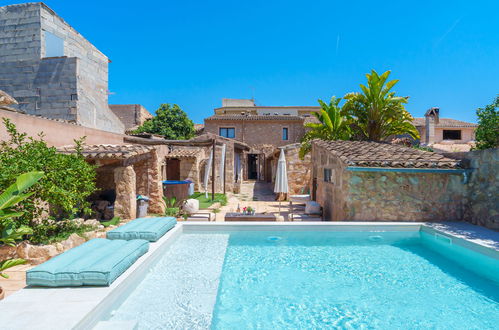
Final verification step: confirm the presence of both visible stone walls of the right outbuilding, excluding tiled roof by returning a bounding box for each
[312,143,467,221]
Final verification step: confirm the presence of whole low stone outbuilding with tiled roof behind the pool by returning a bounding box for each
[311,141,468,221]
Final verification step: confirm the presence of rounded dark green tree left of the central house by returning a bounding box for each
[135,103,195,140]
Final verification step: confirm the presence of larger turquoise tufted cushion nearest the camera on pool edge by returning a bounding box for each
[26,238,149,287]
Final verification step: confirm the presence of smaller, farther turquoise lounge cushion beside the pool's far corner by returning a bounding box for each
[107,217,177,242]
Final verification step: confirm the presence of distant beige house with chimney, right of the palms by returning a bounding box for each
[413,108,478,145]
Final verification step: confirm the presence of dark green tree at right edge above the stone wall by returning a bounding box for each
[473,96,499,150]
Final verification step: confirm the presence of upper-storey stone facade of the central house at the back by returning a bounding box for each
[204,120,305,147]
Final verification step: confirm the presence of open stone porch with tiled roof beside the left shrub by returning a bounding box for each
[58,144,164,219]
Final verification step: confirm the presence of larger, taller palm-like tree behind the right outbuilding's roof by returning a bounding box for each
[343,70,419,141]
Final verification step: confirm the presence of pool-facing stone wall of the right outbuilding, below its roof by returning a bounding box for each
[345,172,466,221]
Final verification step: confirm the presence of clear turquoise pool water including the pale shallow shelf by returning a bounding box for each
[112,232,499,329]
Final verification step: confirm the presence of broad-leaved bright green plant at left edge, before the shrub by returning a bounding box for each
[0,172,43,300]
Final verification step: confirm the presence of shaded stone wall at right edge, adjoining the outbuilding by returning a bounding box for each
[445,148,499,230]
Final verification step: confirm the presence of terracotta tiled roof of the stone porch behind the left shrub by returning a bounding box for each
[57,144,154,160]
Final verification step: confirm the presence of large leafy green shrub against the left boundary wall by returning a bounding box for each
[0,118,96,226]
